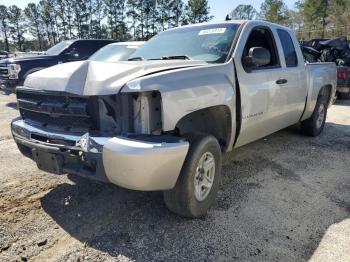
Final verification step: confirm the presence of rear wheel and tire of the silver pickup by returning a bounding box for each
[301,91,328,137]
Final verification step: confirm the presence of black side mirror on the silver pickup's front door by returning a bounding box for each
[242,47,271,72]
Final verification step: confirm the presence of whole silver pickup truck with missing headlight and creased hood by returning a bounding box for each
[12,21,337,218]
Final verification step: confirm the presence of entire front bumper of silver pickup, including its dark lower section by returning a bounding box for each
[11,119,189,191]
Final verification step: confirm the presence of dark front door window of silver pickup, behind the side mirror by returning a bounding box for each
[242,28,280,69]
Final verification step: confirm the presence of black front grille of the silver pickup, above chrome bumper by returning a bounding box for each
[16,88,96,133]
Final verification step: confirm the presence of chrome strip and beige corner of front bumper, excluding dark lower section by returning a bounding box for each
[11,119,189,191]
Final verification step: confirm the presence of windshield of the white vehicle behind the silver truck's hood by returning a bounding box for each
[89,44,138,62]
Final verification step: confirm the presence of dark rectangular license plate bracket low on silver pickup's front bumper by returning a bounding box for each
[32,149,63,175]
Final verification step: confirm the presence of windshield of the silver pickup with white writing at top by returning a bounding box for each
[129,23,239,63]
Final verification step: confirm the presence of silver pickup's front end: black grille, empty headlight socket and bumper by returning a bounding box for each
[12,88,189,191]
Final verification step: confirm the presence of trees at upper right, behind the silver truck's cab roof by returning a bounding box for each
[229,0,350,40]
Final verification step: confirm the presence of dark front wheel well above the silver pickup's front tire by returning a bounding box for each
[176,105,232,151]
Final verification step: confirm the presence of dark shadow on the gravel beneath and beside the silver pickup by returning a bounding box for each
[41,123,350,261]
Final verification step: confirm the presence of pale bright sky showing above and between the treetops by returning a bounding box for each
[0,0,296,21]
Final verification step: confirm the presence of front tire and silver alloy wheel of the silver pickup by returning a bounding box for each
[164,134,222,218]
